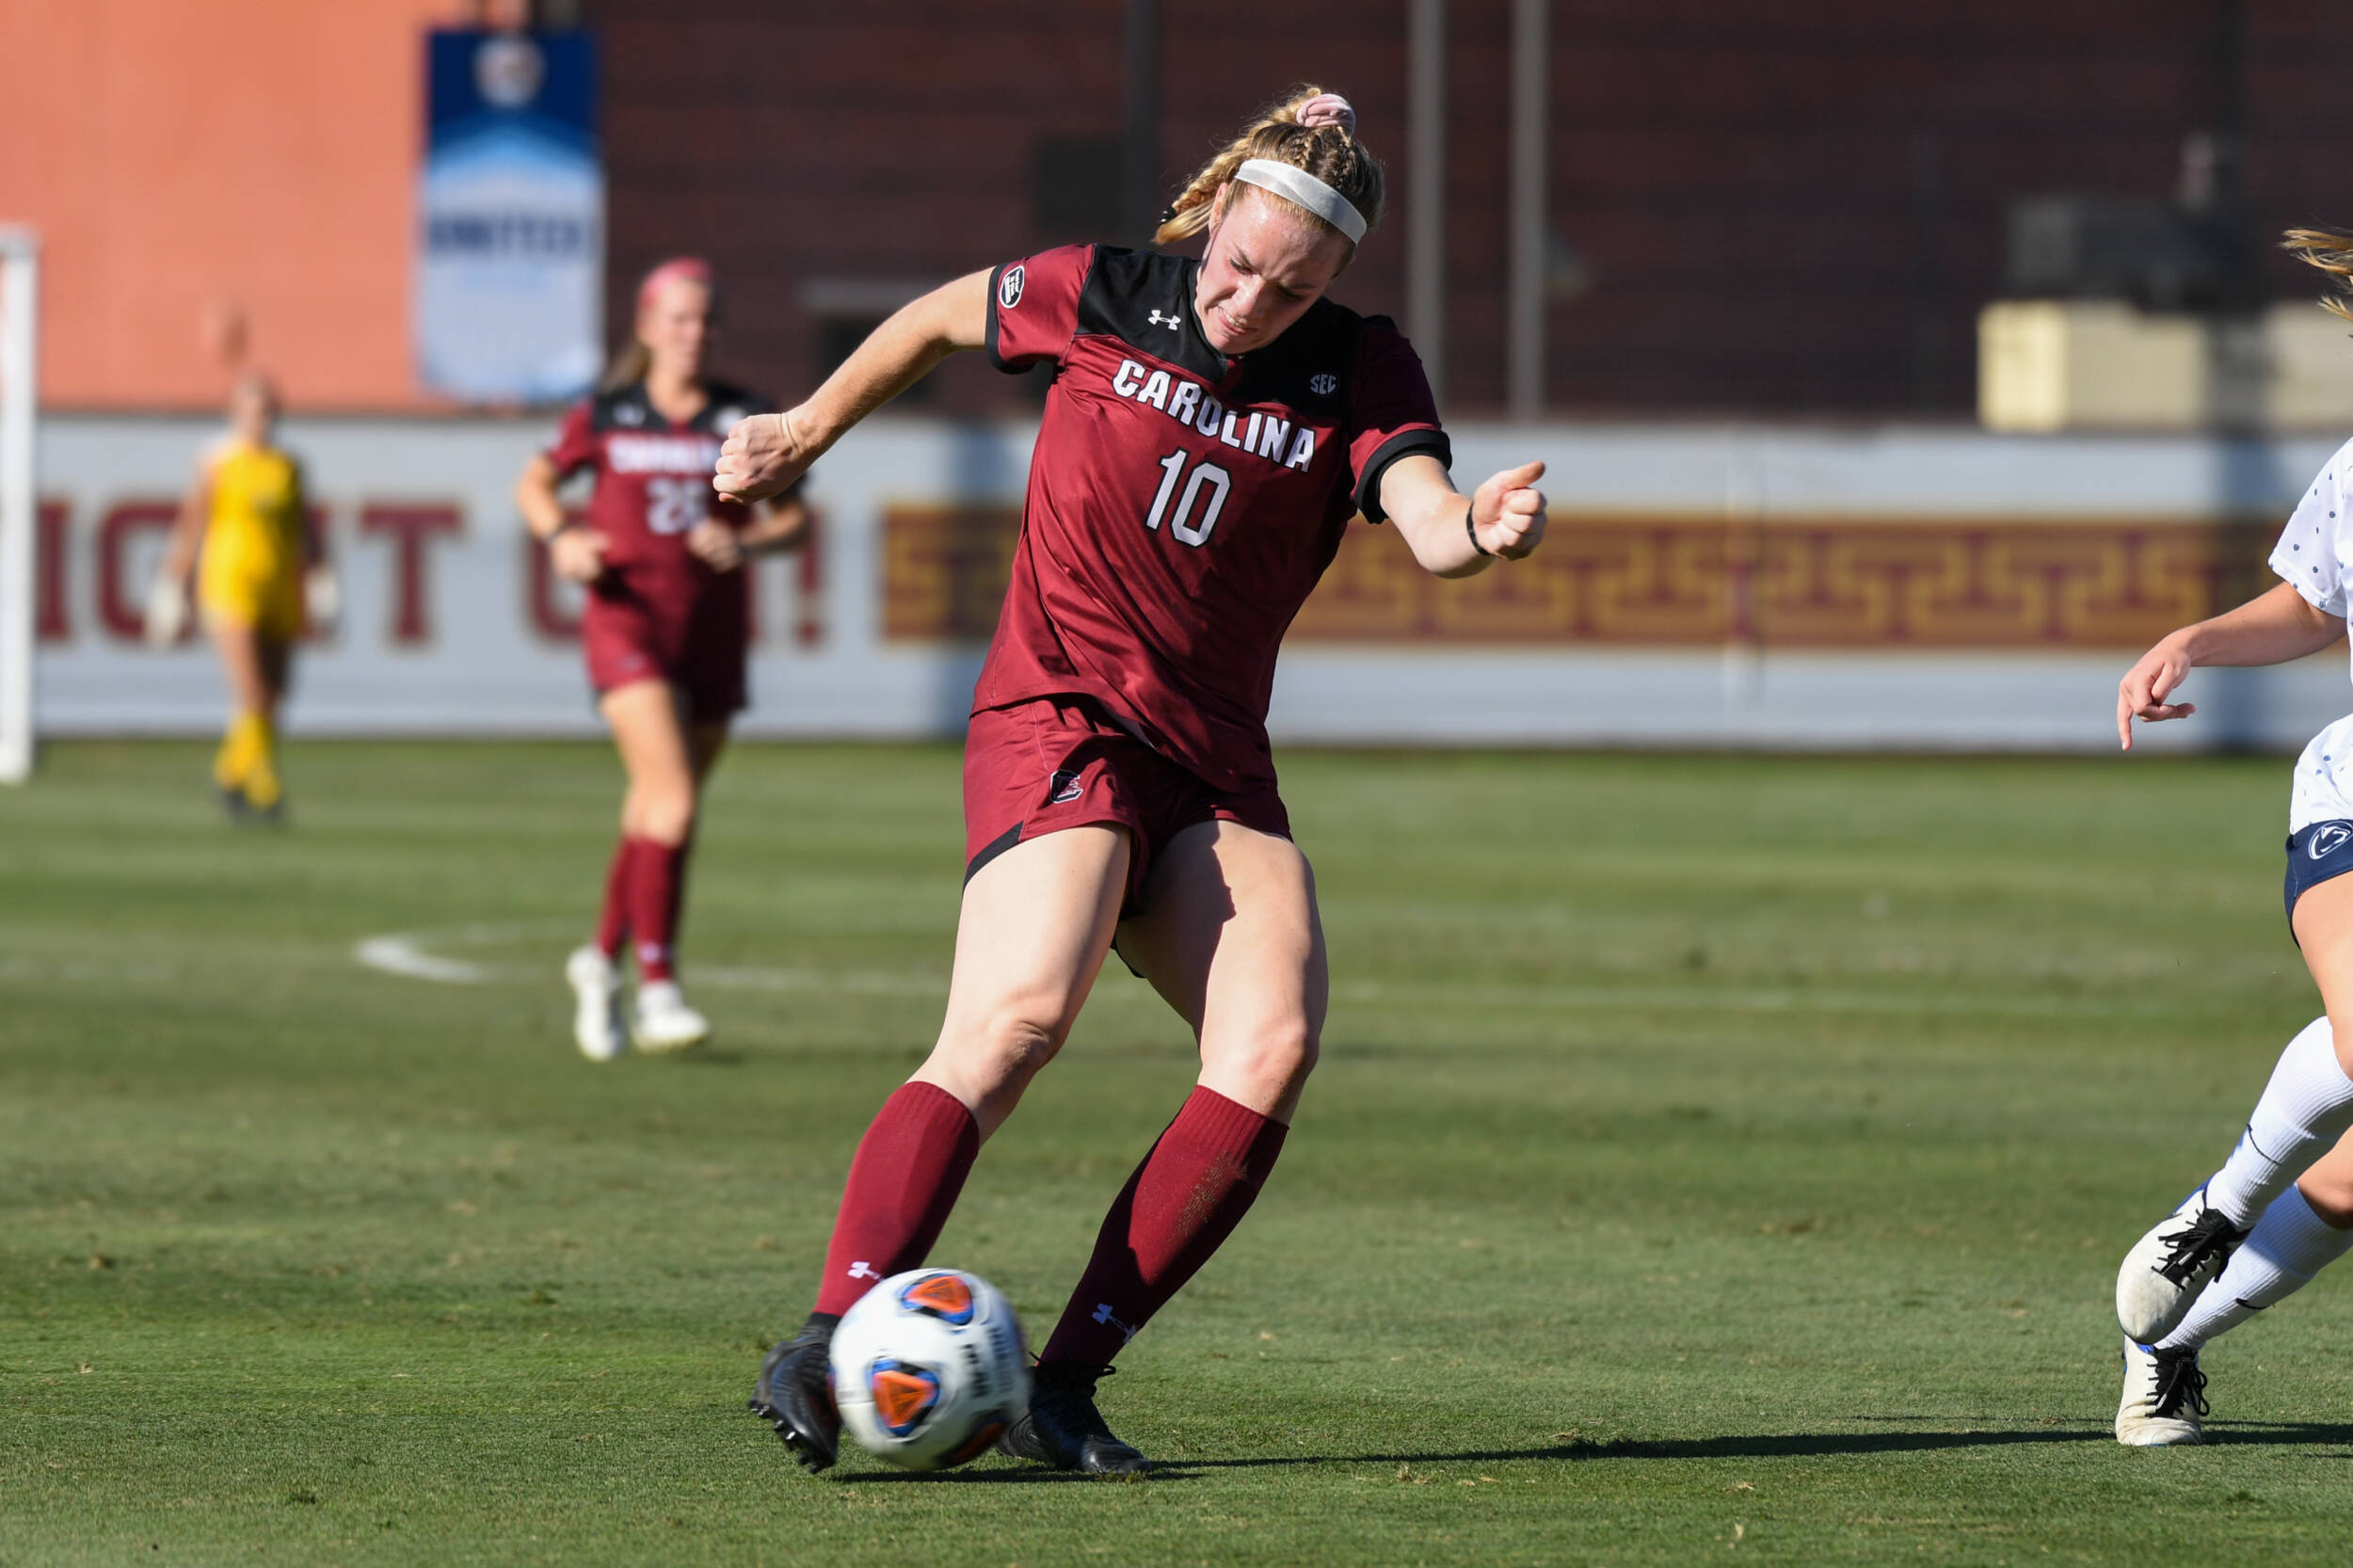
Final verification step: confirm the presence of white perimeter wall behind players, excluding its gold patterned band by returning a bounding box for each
[38,414,2353,748]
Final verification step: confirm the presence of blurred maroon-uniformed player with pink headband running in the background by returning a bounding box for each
[516,259,808,1062]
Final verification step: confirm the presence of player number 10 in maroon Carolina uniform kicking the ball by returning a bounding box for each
[715,89,1544,1471]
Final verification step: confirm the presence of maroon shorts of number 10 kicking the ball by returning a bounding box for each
[965,696,1292,916]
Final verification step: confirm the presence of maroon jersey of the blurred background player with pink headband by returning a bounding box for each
[549,381,776,586]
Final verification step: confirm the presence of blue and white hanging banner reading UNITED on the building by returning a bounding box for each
[414,31,605,403]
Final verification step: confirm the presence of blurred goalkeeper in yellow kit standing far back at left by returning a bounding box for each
[146,375,337,822]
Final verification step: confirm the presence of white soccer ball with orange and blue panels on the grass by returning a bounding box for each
[831,1269,1029,1469]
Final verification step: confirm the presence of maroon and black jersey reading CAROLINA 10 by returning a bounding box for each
[972,245,1452,789]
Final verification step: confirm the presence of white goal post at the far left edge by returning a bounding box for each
[0,226,40,784]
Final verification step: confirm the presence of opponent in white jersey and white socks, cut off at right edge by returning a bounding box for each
[2116,229,2353,1448]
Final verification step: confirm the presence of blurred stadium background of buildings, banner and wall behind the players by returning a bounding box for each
[0,0,2353,748]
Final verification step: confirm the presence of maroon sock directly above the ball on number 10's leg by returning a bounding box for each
[817,1083,982,1316]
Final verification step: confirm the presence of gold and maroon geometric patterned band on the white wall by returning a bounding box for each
[883,506,2278,649]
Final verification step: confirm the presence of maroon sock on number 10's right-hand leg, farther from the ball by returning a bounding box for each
[1038,1088,1289,1363]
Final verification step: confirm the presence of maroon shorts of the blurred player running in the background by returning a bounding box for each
[582,574,751,723]
